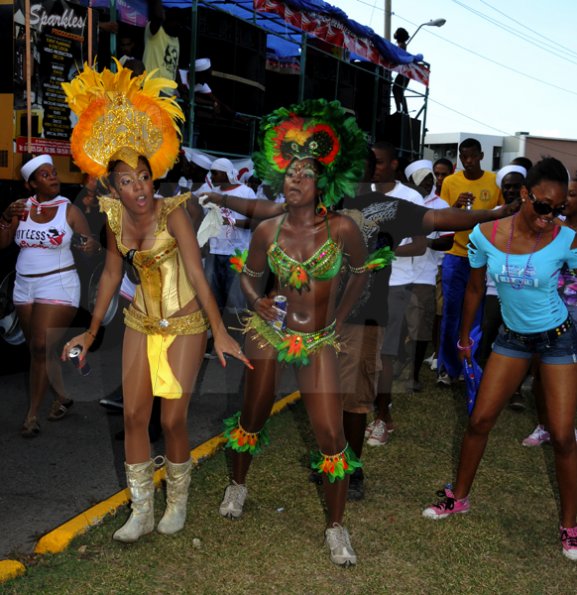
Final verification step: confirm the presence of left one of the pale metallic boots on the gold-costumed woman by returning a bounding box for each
[112,461,154,543]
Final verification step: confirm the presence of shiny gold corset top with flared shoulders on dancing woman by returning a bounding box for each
[99,193,196,318]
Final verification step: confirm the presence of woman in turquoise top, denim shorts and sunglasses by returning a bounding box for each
[423,158,577,561]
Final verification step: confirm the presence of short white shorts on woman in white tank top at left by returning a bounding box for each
[12,270,80,308]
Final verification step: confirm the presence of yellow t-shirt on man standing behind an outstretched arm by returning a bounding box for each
[441,171,504,258]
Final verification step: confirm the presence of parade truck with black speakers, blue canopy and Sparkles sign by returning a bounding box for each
[0,0,428,177]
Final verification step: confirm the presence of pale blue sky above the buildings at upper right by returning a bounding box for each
[327,0,577,139]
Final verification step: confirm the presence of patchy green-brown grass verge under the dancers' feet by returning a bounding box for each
[0,371,577,595]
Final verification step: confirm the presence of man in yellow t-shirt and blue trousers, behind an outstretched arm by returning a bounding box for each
[437,138,503,384]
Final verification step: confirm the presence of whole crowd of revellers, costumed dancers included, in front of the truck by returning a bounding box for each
[0,54,577,566]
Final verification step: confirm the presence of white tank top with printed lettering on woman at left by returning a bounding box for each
[14,196,74,275]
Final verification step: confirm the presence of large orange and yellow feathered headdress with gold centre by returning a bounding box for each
[62,60,184,179]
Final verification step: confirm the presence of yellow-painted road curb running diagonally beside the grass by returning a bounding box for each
[0,391,300,584]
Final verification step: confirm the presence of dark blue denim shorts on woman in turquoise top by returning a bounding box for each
[493,324,577,365]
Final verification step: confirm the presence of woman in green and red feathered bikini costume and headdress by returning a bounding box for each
[220,100,384,565]
